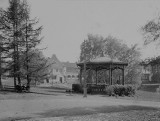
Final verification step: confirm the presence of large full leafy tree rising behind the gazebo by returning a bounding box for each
[80,35,141,84]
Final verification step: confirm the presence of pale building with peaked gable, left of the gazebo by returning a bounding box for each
[44,54,79,85]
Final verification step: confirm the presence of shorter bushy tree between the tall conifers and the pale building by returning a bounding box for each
[21,49,50,86]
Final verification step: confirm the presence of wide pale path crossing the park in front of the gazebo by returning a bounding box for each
[0,94,160,120]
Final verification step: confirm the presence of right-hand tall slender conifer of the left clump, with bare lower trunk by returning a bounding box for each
[18,1,42,86]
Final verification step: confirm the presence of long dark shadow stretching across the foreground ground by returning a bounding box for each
[35,105,160,118]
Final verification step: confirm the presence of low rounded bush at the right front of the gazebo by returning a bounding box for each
[106,85,135,96]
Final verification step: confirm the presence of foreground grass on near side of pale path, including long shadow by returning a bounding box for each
[14,106,160,121]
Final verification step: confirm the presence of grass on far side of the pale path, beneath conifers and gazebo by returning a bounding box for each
[0,87,160,102]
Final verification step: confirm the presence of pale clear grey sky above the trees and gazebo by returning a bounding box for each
[0,0,160,62]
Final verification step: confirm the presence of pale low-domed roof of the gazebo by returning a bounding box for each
[77,57,128,66]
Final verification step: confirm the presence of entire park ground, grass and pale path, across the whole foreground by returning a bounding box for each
[0,84,160,121]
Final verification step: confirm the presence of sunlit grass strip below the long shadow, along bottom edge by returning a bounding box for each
[18,110,160,121]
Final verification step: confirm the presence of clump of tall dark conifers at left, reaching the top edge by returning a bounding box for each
[0,0,42,89]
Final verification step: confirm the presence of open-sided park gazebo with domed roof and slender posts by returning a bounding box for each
[77,57,128,92]
